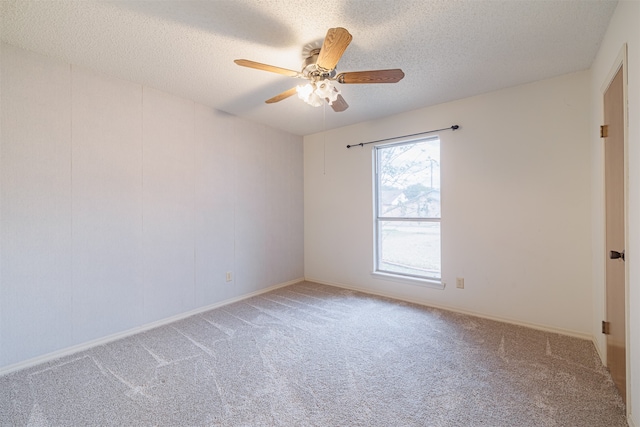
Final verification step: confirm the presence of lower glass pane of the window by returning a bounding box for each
[378,221,441,279]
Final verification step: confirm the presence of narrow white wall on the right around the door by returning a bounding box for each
[590,1,640,426]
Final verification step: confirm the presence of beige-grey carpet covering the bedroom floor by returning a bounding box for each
[0,282,627,427]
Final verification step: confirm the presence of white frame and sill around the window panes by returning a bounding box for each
[371,135,444,289]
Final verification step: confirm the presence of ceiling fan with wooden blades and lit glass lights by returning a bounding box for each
[234,27,404,112]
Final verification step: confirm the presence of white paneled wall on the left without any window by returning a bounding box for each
[0,44,303,368]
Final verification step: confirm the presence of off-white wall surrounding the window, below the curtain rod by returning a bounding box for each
[304,72,592,336]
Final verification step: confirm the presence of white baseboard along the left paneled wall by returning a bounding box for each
[0,278,304,376]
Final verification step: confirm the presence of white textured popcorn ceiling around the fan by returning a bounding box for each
[0,0,616,135]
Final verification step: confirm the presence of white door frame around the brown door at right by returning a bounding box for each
[596,43,633,417]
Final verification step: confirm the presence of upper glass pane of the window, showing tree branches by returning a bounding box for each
[377,138,440,218]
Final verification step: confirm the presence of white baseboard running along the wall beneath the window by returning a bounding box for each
[305,277,598,342]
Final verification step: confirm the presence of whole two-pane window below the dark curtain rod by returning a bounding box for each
[374,137,442,282]
